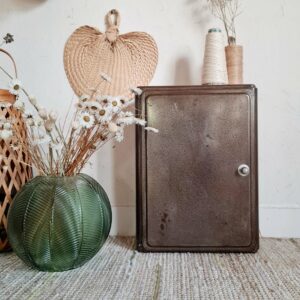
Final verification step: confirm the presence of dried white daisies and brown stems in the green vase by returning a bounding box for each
[0,38,158,176]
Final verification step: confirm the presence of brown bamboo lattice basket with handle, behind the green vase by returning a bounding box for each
[0,49,32,252]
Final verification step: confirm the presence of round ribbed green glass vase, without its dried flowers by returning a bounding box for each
[8,174,112,272]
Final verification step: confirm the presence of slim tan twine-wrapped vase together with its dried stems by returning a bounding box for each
[207,0,243,84]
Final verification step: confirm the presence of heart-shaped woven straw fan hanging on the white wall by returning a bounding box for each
[64,10,158,96]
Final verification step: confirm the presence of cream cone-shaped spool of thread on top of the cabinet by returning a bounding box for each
[202,28,228,84]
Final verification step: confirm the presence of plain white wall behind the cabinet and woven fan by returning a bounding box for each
[0,0,300,237]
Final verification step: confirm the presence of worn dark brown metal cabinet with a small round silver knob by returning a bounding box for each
[138,87,258,251]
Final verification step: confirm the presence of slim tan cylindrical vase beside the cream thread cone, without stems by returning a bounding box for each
[225,45,243,84]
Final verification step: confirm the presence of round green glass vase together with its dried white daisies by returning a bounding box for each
[0,50,157,271]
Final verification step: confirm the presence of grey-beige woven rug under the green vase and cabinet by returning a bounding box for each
[0,238,300,300]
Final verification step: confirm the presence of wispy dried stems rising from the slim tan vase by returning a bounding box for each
[207,0,241,45]
